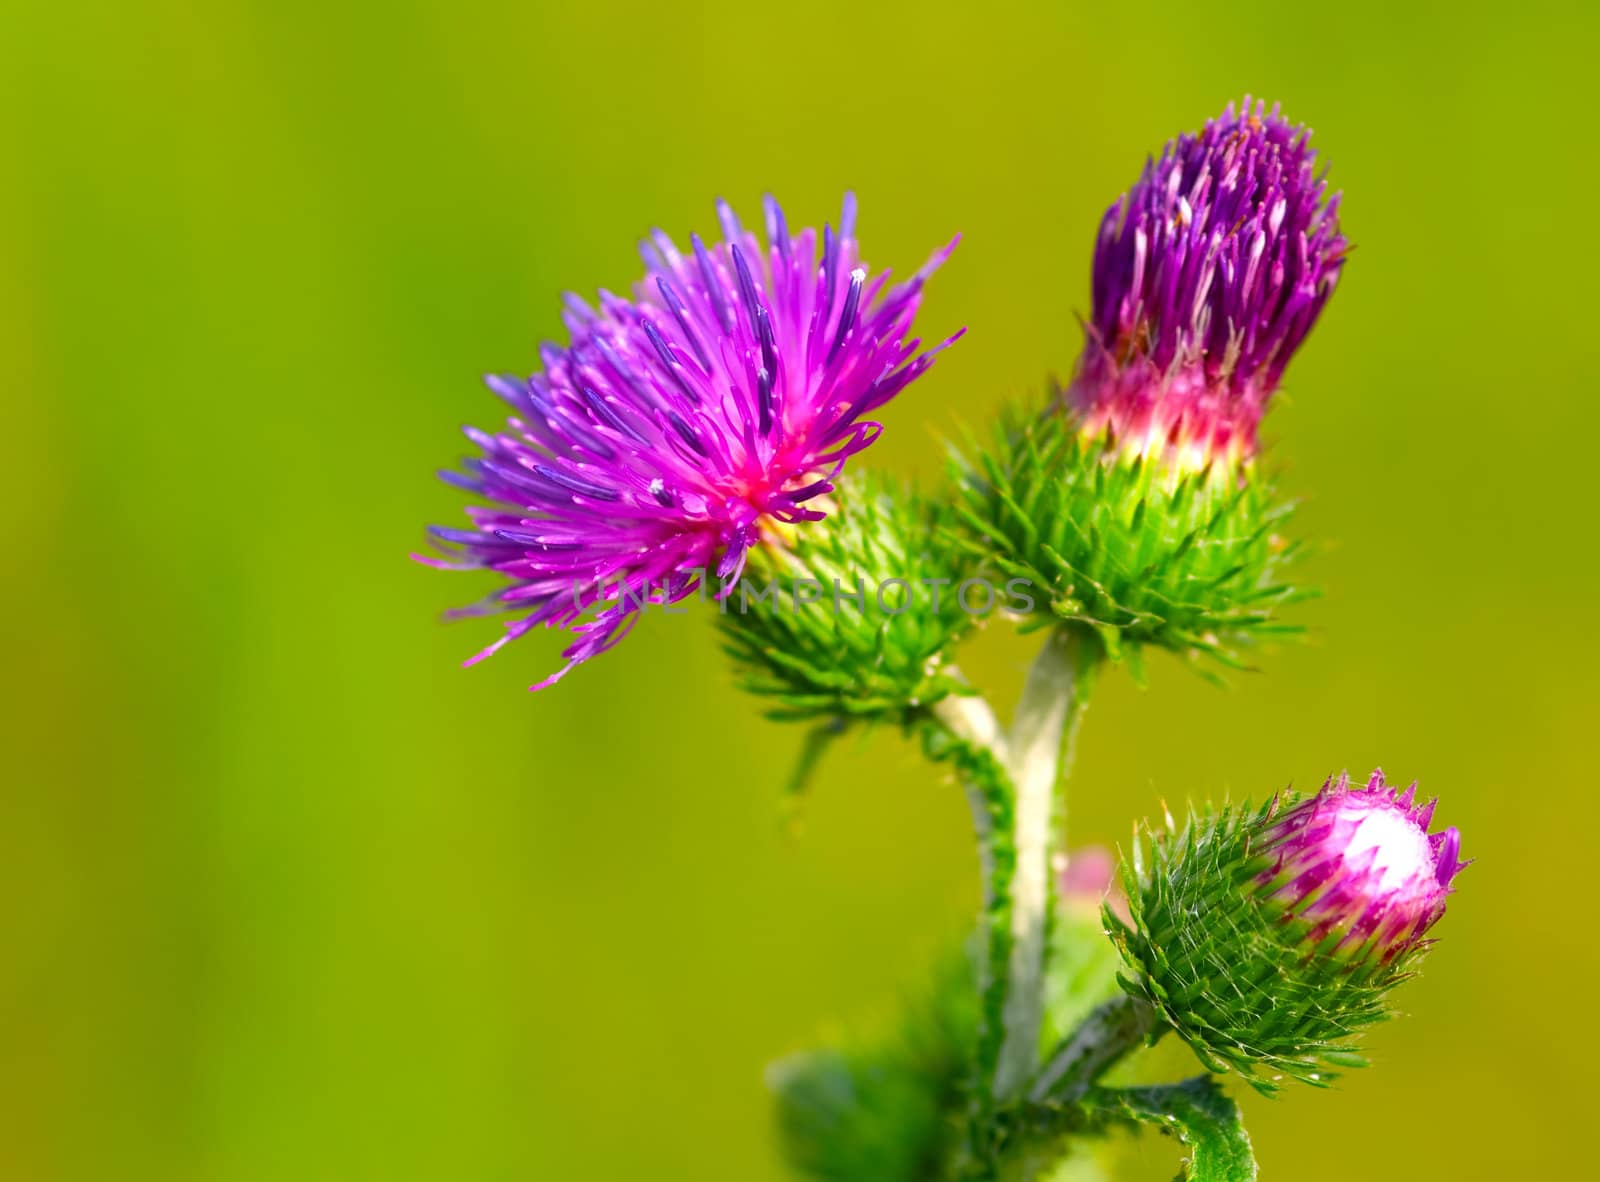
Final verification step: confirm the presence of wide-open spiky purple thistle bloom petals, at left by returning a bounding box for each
[418,194,960,689]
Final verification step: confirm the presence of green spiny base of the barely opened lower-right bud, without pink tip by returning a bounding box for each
[1102,798,1446,1094]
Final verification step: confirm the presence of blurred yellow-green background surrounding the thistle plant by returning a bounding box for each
[0,0,1600,1182]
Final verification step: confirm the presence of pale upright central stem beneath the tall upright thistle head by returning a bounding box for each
[994,629,1099,1100]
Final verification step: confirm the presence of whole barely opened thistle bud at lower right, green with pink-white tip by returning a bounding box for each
[1104,773,1464,1091]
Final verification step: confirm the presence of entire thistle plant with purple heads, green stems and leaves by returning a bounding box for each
[421,98,1462,1182]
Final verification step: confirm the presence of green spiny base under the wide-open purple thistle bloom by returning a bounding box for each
[720,477,978,721]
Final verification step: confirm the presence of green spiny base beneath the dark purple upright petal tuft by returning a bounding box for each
[955,406,1306,665]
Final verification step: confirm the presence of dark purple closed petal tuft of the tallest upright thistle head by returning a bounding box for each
[1067,96,1349,469]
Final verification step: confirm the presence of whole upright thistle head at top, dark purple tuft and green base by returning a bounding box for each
[962,98,1349,664]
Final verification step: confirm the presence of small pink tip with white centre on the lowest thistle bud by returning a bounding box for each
[1256,771,1466,961]
